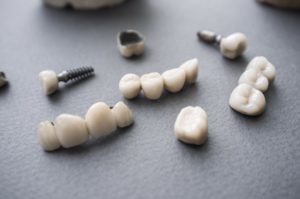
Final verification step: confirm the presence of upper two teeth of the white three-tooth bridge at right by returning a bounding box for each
[239,57,276,92]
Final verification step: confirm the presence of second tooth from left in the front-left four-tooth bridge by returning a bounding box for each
[54,114,89,148]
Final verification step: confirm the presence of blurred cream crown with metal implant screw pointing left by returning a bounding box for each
[197,30,247,59]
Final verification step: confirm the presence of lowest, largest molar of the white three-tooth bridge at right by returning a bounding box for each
[229,84,266,116]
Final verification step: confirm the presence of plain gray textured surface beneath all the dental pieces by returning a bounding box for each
[0,0,300,199]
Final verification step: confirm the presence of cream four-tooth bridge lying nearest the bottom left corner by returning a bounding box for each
[37,102,133,151]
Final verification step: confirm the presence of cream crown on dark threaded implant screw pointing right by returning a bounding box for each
[39,66,94,95]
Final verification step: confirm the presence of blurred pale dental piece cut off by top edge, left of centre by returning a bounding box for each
[44,0,124,10]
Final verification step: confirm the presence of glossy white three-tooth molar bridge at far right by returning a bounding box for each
[229,57,276,116]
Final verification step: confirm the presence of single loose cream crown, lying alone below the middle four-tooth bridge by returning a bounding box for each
[174,106,208,145]
